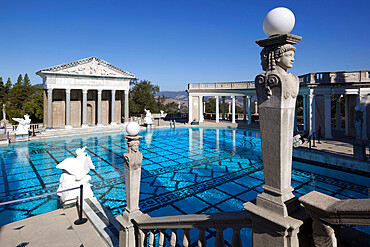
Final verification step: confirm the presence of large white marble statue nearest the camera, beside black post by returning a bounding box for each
[56,147,95,204]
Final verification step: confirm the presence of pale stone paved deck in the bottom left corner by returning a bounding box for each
[0,207,106,247]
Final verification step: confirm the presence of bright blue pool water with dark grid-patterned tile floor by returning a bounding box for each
[0,128,369,243]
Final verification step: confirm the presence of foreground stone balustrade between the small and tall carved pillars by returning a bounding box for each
[134,211,252,247]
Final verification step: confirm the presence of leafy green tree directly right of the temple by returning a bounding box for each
[130,79,160,115]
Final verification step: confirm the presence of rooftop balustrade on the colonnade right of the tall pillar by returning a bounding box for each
[299,70,370,83]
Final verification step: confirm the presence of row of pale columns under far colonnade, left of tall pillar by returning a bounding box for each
[188,94,258,124]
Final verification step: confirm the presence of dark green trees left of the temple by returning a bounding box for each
[0,73,43,124]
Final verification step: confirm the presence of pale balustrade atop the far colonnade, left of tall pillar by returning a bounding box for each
[188,81,255,90]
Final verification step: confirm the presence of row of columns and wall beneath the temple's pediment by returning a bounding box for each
[45,88,129,128]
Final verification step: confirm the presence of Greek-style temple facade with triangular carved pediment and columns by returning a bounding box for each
[36,57,135,128]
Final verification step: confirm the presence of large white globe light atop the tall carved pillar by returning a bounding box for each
[263,7,295,37]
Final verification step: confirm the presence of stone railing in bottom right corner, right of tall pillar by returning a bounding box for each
[299,191,370,247]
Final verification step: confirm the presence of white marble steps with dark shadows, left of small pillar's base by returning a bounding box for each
[83,197,119,247]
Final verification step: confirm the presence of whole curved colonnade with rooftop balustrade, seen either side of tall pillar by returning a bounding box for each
[187,71,370,140]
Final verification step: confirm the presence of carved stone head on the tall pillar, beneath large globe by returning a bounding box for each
[261,44,296,71]
